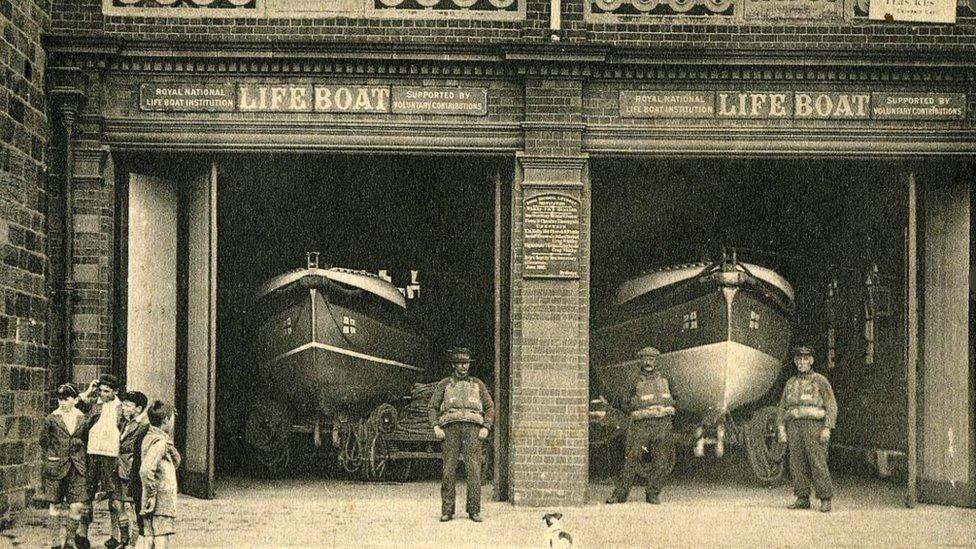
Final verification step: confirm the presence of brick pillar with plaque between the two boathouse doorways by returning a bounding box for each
[509,78,590,506]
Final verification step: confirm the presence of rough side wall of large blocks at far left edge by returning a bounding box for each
[0,1,50,527]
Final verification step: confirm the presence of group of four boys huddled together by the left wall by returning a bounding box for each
[38,374,180,549]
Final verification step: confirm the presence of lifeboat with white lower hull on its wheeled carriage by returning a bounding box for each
[590,250,795,481]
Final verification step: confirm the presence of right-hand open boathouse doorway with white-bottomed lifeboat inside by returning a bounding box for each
[590,156,976,503]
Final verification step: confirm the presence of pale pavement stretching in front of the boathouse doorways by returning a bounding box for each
[0,478,976,548]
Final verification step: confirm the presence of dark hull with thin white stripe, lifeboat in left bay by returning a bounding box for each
[255,270,429,416]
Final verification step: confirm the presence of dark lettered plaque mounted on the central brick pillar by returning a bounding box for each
[522,192,580,279]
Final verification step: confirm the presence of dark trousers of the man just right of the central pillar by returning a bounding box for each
[613,417,674,501]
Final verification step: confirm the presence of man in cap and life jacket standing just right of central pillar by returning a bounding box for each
[607,347,675,504]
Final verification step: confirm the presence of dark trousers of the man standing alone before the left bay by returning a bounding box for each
[441,421,481,515]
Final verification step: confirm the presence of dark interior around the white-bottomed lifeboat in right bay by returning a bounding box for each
[590,158,944,490]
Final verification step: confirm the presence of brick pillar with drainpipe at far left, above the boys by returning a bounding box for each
[49,66,115,386]
